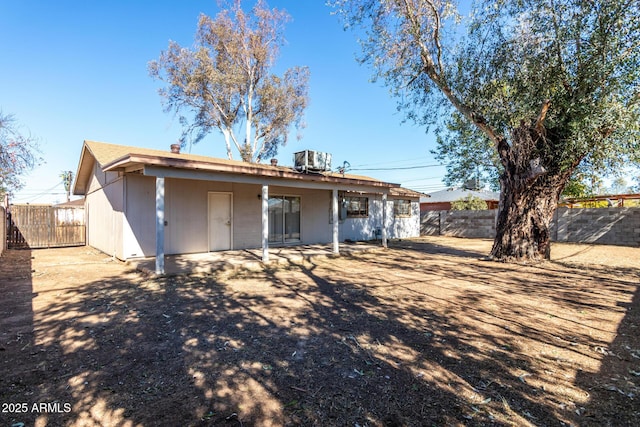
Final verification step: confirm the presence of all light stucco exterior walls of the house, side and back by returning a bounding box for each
[87,169,420,259]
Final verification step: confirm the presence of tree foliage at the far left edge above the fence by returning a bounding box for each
[0,111,41,195]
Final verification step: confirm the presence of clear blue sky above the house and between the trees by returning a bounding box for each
[0,0,445,203]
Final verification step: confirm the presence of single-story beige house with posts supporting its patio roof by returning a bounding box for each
[73,141,420,274]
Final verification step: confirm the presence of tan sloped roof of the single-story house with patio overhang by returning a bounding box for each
[73,141,400,195]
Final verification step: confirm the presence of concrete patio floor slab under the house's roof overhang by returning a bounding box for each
[127,242,383,276]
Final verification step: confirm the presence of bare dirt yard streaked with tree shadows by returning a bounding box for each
[0,238,640,427]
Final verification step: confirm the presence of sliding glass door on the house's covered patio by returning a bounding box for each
[269,196,300,244]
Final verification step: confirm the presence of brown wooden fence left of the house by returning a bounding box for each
[7,205,85,249]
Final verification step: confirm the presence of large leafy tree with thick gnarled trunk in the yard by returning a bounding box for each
[331,0,640,260]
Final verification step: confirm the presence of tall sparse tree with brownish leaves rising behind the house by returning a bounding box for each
[149,0,309,162]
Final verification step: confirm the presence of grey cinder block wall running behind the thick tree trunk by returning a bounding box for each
[420,208,640,246]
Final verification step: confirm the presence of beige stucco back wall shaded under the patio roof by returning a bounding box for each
[118,175,370,258]
